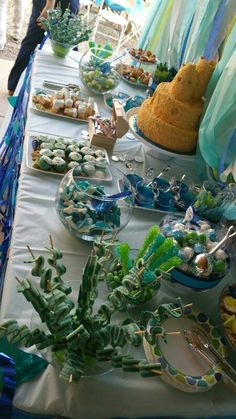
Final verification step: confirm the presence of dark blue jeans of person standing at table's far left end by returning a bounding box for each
[8,0,79,91]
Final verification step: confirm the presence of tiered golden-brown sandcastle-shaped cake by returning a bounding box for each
[137,58,215,153]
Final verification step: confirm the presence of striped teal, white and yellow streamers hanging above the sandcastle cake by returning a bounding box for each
[138,0,236,69]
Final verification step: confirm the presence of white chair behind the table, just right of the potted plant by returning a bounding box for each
[92,0,128,52]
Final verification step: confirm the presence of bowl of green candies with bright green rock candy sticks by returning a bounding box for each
[105,226,181,306]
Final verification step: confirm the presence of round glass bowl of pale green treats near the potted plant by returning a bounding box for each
[79,49,120,95]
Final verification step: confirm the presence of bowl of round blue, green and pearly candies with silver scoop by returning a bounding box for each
[161,217,230,290]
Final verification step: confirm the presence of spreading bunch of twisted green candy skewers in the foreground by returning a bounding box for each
[0,230,183,382]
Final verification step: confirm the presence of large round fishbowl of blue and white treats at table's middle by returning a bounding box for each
[56,163,134,241]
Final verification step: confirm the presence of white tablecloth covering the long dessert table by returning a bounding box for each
[1,47,236,419]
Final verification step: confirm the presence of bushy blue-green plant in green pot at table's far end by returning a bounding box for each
[40,7,91,58]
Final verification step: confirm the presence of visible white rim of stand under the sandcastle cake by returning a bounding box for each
[126,107,195,161]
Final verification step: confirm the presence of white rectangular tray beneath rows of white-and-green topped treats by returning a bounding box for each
[26,133,113,182]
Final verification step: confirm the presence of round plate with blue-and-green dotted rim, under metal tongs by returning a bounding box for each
[143,312,227,393]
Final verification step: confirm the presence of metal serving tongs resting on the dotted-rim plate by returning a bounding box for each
[184,327,236,391]
